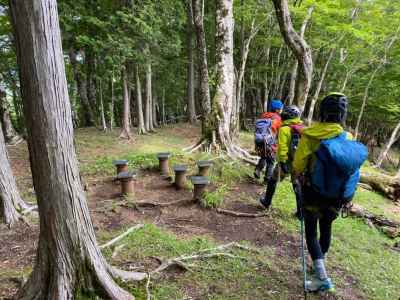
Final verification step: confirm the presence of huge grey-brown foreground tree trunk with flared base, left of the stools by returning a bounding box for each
[10,0,141,300]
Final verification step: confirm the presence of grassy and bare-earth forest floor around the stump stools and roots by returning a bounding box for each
[0,124,400,300]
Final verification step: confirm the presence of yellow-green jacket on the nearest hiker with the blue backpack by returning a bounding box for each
[293,123,353,175]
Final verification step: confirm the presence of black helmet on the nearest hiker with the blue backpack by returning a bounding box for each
[319,93,348,123]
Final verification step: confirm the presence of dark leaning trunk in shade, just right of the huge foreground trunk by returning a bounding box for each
[69,49,95,127]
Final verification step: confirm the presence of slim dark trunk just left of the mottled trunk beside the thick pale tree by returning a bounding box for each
[186,0,196,123]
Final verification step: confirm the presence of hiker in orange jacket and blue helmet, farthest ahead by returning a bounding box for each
[254,99,283,182]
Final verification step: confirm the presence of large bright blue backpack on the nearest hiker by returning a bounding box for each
[311,132,368,207]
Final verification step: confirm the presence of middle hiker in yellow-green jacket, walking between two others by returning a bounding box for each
[260,105,304,217]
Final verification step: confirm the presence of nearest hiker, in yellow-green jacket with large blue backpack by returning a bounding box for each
[293,93,368,292]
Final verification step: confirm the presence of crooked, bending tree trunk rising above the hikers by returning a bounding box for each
[273,0,314,112]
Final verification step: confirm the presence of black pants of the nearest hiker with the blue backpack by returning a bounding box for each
[303,186,339,260]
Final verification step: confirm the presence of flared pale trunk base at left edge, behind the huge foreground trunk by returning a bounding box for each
[0,126,28,226]
